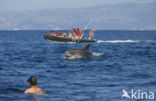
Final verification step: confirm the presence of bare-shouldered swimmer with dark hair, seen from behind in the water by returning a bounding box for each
[24,76,45,94]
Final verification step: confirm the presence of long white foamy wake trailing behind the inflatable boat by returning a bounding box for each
[97,40,156,43]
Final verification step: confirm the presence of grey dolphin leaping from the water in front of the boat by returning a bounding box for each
[64,44,103,59]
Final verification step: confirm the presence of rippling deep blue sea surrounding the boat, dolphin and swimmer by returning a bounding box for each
[0,30,156,101]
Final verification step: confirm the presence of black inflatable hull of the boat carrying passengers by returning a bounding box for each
[44,34,97,42]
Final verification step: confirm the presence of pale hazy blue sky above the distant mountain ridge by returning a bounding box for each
[0,0,156,12]
